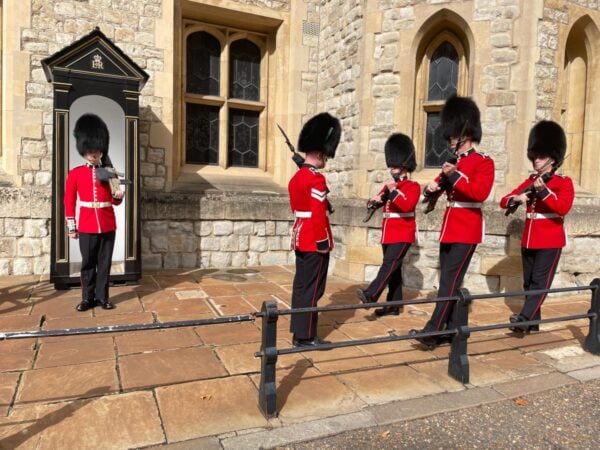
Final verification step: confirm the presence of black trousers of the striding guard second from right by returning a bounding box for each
[425,243,477,331]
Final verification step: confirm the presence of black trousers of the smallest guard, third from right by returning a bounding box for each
[365,242,410,302]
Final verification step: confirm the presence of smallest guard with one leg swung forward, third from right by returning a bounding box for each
[356,133,421,316]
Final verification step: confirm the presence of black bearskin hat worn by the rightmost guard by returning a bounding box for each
[527,120,567,167]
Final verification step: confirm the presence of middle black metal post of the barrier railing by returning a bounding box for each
[448,288,471,384]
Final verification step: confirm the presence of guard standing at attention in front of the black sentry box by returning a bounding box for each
[64,114,123,311]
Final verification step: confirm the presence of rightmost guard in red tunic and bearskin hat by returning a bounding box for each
[500,120,575,333]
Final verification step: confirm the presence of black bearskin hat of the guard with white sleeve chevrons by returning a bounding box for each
[298,112,342,158]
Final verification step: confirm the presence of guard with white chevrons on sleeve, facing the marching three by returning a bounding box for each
[288,113,342,347]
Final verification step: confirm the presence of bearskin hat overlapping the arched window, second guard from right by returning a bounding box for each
[441,95,481,143]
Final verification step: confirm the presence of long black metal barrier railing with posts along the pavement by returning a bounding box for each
[0,278,600,417]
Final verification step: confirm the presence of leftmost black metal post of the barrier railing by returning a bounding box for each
[258,302,279,418]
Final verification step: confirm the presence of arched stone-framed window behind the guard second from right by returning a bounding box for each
[413,31,467,169]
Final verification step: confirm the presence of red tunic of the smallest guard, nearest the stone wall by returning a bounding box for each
[378,178,421,244]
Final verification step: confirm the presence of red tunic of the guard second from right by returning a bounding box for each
[436,149,494,244]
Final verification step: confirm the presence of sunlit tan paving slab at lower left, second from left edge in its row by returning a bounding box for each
[15,360,119,403]
